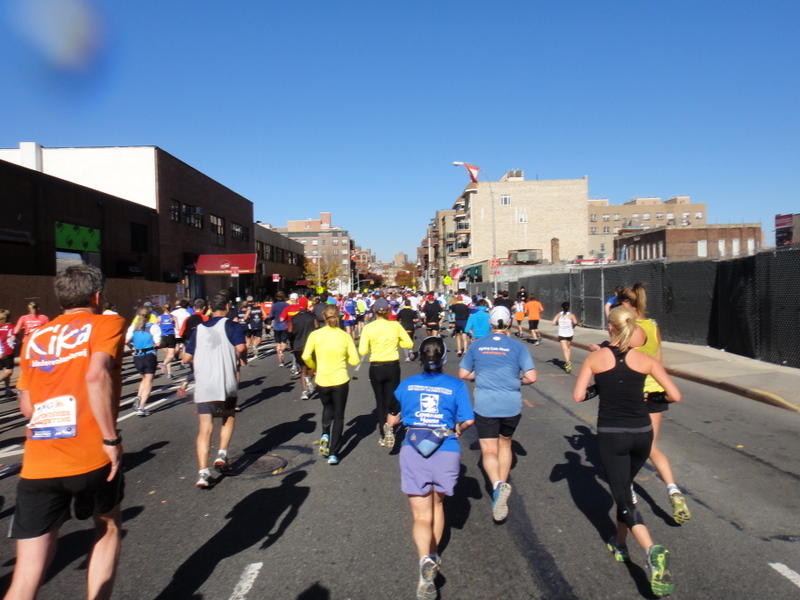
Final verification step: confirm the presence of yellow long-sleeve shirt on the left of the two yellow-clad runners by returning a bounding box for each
[303,326,358,387]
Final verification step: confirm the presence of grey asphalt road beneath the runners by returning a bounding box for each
[0,330,800,600]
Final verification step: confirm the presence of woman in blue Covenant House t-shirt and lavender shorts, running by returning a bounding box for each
[388,336,475,600]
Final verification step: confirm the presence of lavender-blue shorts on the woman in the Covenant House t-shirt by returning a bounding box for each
[400,445,461,496]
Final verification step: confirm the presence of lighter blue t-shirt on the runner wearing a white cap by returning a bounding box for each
[461,333,536,417]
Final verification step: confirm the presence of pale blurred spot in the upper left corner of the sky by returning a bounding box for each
[5,0,112,110]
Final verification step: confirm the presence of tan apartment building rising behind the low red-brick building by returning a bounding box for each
[585,196,707,258]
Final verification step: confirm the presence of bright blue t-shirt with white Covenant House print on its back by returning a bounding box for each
[394,373,475,452]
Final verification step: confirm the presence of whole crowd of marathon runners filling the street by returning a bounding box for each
[0,278,691,600]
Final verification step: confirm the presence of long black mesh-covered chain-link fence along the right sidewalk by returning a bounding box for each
[460,248,800,368]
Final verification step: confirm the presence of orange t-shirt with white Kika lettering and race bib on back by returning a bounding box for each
[17,312,126,479]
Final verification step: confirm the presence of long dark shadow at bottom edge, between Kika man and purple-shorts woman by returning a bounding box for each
[156,471,312,600]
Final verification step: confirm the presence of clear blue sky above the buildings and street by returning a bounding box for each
[0,0,800,260]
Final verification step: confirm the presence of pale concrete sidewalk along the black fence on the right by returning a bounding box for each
[540,322,800,412]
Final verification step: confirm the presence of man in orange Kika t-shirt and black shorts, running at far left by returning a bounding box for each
[6,264,125,598]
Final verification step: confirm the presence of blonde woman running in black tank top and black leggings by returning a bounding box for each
[573,306,681,597]
